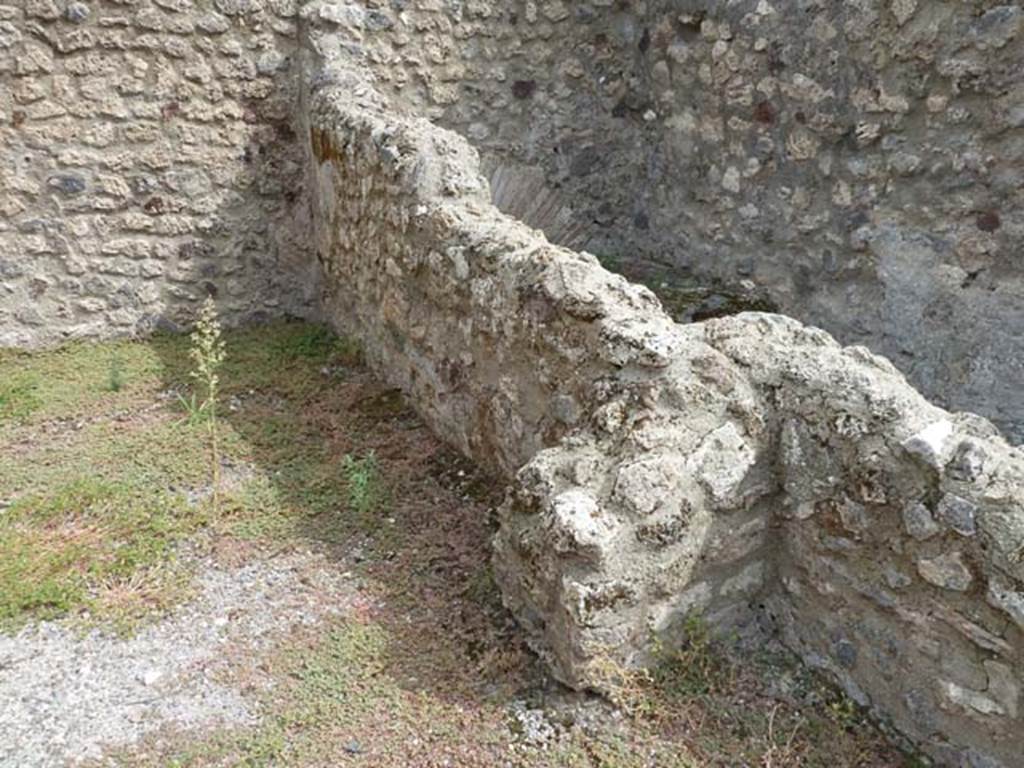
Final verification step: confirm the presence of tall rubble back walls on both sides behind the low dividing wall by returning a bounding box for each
[0,0,1024,450]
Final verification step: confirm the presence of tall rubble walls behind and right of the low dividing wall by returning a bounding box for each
[337,0,1024,440]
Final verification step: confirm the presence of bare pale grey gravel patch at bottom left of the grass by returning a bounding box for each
[0,552,355,768]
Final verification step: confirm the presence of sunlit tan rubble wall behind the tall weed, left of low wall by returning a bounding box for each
[0,0,314,345]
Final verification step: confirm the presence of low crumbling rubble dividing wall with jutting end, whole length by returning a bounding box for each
[307,46,1024,768]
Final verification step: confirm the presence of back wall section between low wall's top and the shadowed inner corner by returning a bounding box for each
[304,0,651,249]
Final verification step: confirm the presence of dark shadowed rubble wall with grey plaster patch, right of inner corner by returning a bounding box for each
[637,0,1024,440]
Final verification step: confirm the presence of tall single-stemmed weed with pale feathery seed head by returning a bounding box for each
[178,296,226,512]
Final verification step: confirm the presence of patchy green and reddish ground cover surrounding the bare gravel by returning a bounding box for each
[0,323,909,768]
